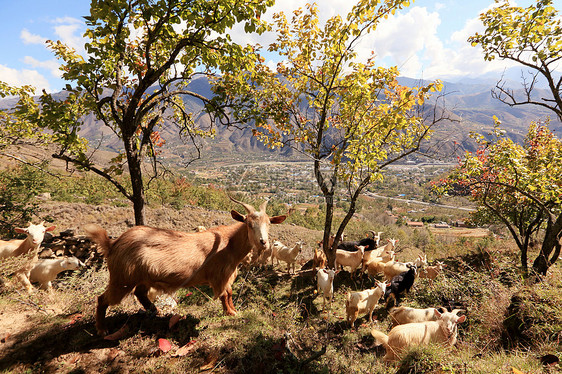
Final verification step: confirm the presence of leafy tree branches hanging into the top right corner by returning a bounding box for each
[468,0,562,120]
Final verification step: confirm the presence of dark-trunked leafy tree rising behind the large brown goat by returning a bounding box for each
[3,0,273,224]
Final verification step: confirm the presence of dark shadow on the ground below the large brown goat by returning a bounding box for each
[0,311,199,372]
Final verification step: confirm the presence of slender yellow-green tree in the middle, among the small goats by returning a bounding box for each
[210,0,441,260]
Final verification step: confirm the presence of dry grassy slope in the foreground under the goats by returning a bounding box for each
[0,197,562,373]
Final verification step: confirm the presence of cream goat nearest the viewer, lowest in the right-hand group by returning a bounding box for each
[371,309,466,361]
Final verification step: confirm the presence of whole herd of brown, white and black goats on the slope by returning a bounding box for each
[0,197,466,361]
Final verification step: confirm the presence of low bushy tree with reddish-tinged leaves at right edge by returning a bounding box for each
[438,120,562,274]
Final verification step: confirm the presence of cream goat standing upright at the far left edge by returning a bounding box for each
[0,221,56,292]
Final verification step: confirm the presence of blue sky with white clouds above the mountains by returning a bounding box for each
[0,0,562,91]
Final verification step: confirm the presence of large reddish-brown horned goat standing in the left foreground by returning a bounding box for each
[85,196,286,335]
